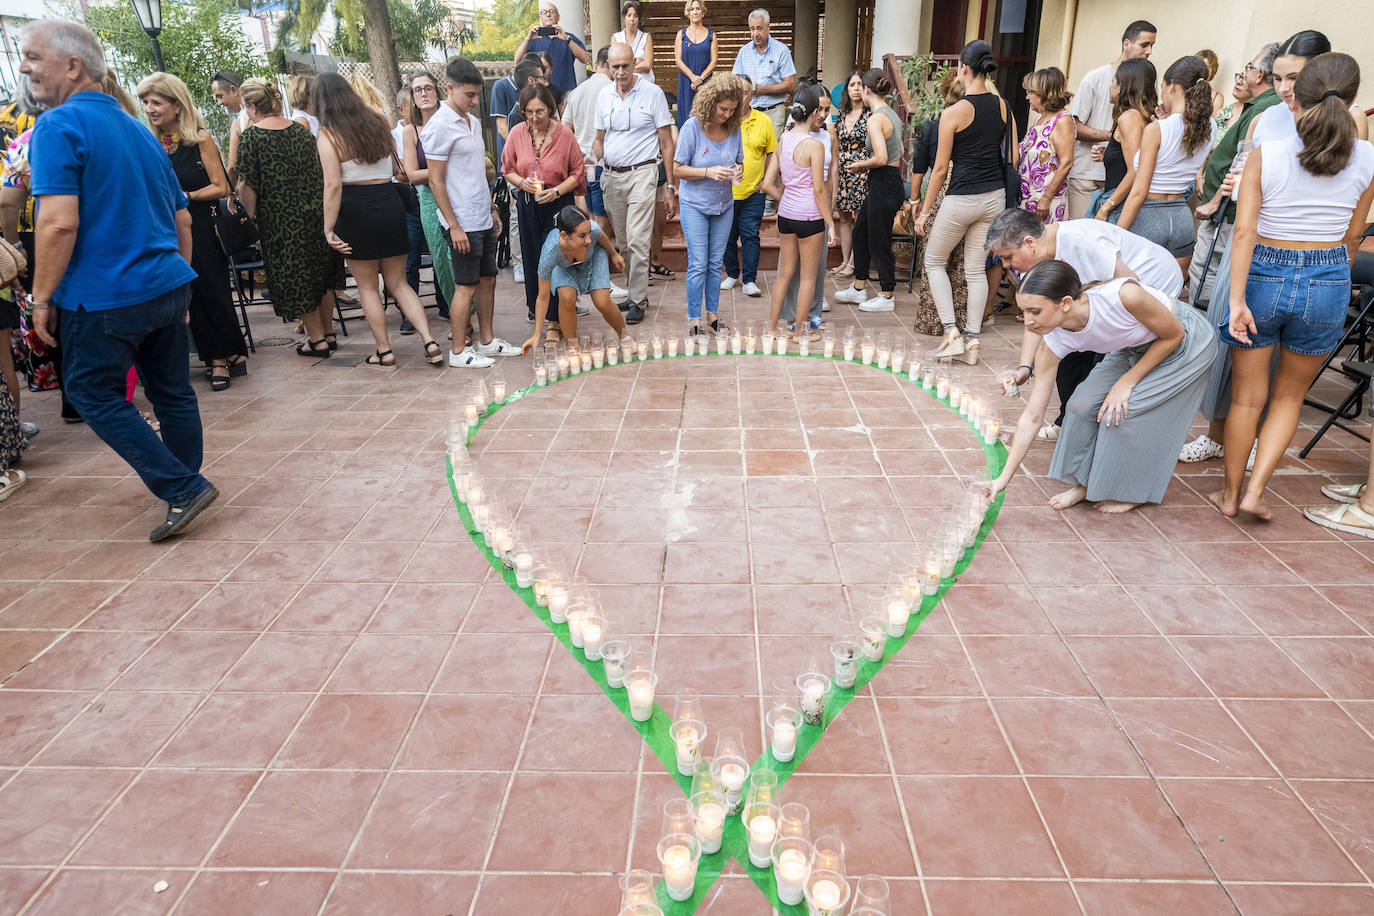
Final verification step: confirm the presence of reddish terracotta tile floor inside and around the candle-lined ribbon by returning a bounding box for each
[0,275,1374,916]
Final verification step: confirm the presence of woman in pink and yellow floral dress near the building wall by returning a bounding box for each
[1018,67,1074,224]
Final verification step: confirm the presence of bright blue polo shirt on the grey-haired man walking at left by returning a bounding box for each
[29,92,195,312]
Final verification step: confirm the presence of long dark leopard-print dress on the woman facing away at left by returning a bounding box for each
[238,121,345,321]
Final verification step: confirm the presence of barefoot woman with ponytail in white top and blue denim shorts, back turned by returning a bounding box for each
[1210,54,1374,519]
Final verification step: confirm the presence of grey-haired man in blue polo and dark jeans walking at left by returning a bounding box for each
[19,19,218,541]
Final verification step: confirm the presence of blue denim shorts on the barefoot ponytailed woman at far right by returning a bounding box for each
[1221,244,1351,356]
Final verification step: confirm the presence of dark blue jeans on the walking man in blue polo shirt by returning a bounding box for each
[58,284,210,503]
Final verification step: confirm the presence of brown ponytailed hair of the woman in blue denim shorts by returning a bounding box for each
[1293,52,1360,174]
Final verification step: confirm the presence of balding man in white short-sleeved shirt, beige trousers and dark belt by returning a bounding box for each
[592,44,677,324]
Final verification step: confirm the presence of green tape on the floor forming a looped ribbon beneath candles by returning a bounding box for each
[444,347,1007,916]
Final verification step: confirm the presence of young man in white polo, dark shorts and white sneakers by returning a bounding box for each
[420,58,519,368]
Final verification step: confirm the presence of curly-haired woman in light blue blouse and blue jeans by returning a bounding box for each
[673,73,747,334]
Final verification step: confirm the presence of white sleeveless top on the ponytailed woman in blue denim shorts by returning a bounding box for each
[1257,137,1374,246]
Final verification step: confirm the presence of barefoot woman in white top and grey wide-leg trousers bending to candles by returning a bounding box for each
[991,260,1216,514]
